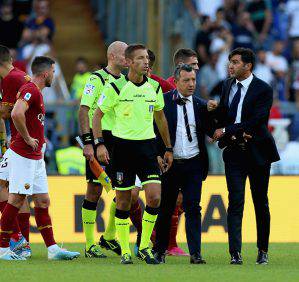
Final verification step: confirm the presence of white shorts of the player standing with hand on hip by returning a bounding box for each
[8,150,48,195]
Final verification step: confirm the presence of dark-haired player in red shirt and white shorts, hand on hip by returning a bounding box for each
[0,57,80,260]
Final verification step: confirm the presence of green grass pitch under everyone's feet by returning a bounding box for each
[0,243,299,282]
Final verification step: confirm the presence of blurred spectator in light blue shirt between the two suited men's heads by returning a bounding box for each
[198,52,220,99]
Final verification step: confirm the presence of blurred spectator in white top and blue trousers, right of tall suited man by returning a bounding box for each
[266,40,288,101]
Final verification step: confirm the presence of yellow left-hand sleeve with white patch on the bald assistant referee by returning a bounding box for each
[81,74,104,108]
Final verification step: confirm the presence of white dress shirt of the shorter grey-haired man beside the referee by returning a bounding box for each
[173,93,199,159]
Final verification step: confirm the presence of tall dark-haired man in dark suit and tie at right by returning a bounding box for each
[214,48,279,264]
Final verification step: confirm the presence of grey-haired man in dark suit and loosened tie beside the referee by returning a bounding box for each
[154,64,217,264]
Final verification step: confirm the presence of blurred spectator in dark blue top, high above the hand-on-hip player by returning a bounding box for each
[22,0,55,44]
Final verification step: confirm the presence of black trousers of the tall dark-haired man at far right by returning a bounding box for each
[223,146,271,254]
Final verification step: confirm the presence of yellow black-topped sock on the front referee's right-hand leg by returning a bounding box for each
[139,206,159,250]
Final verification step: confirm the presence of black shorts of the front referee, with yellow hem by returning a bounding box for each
[110,137,161,190]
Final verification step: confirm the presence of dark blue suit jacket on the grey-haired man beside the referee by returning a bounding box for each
[157,89,214,180]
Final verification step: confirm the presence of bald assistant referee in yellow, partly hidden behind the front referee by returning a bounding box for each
[79,41,127,258]
